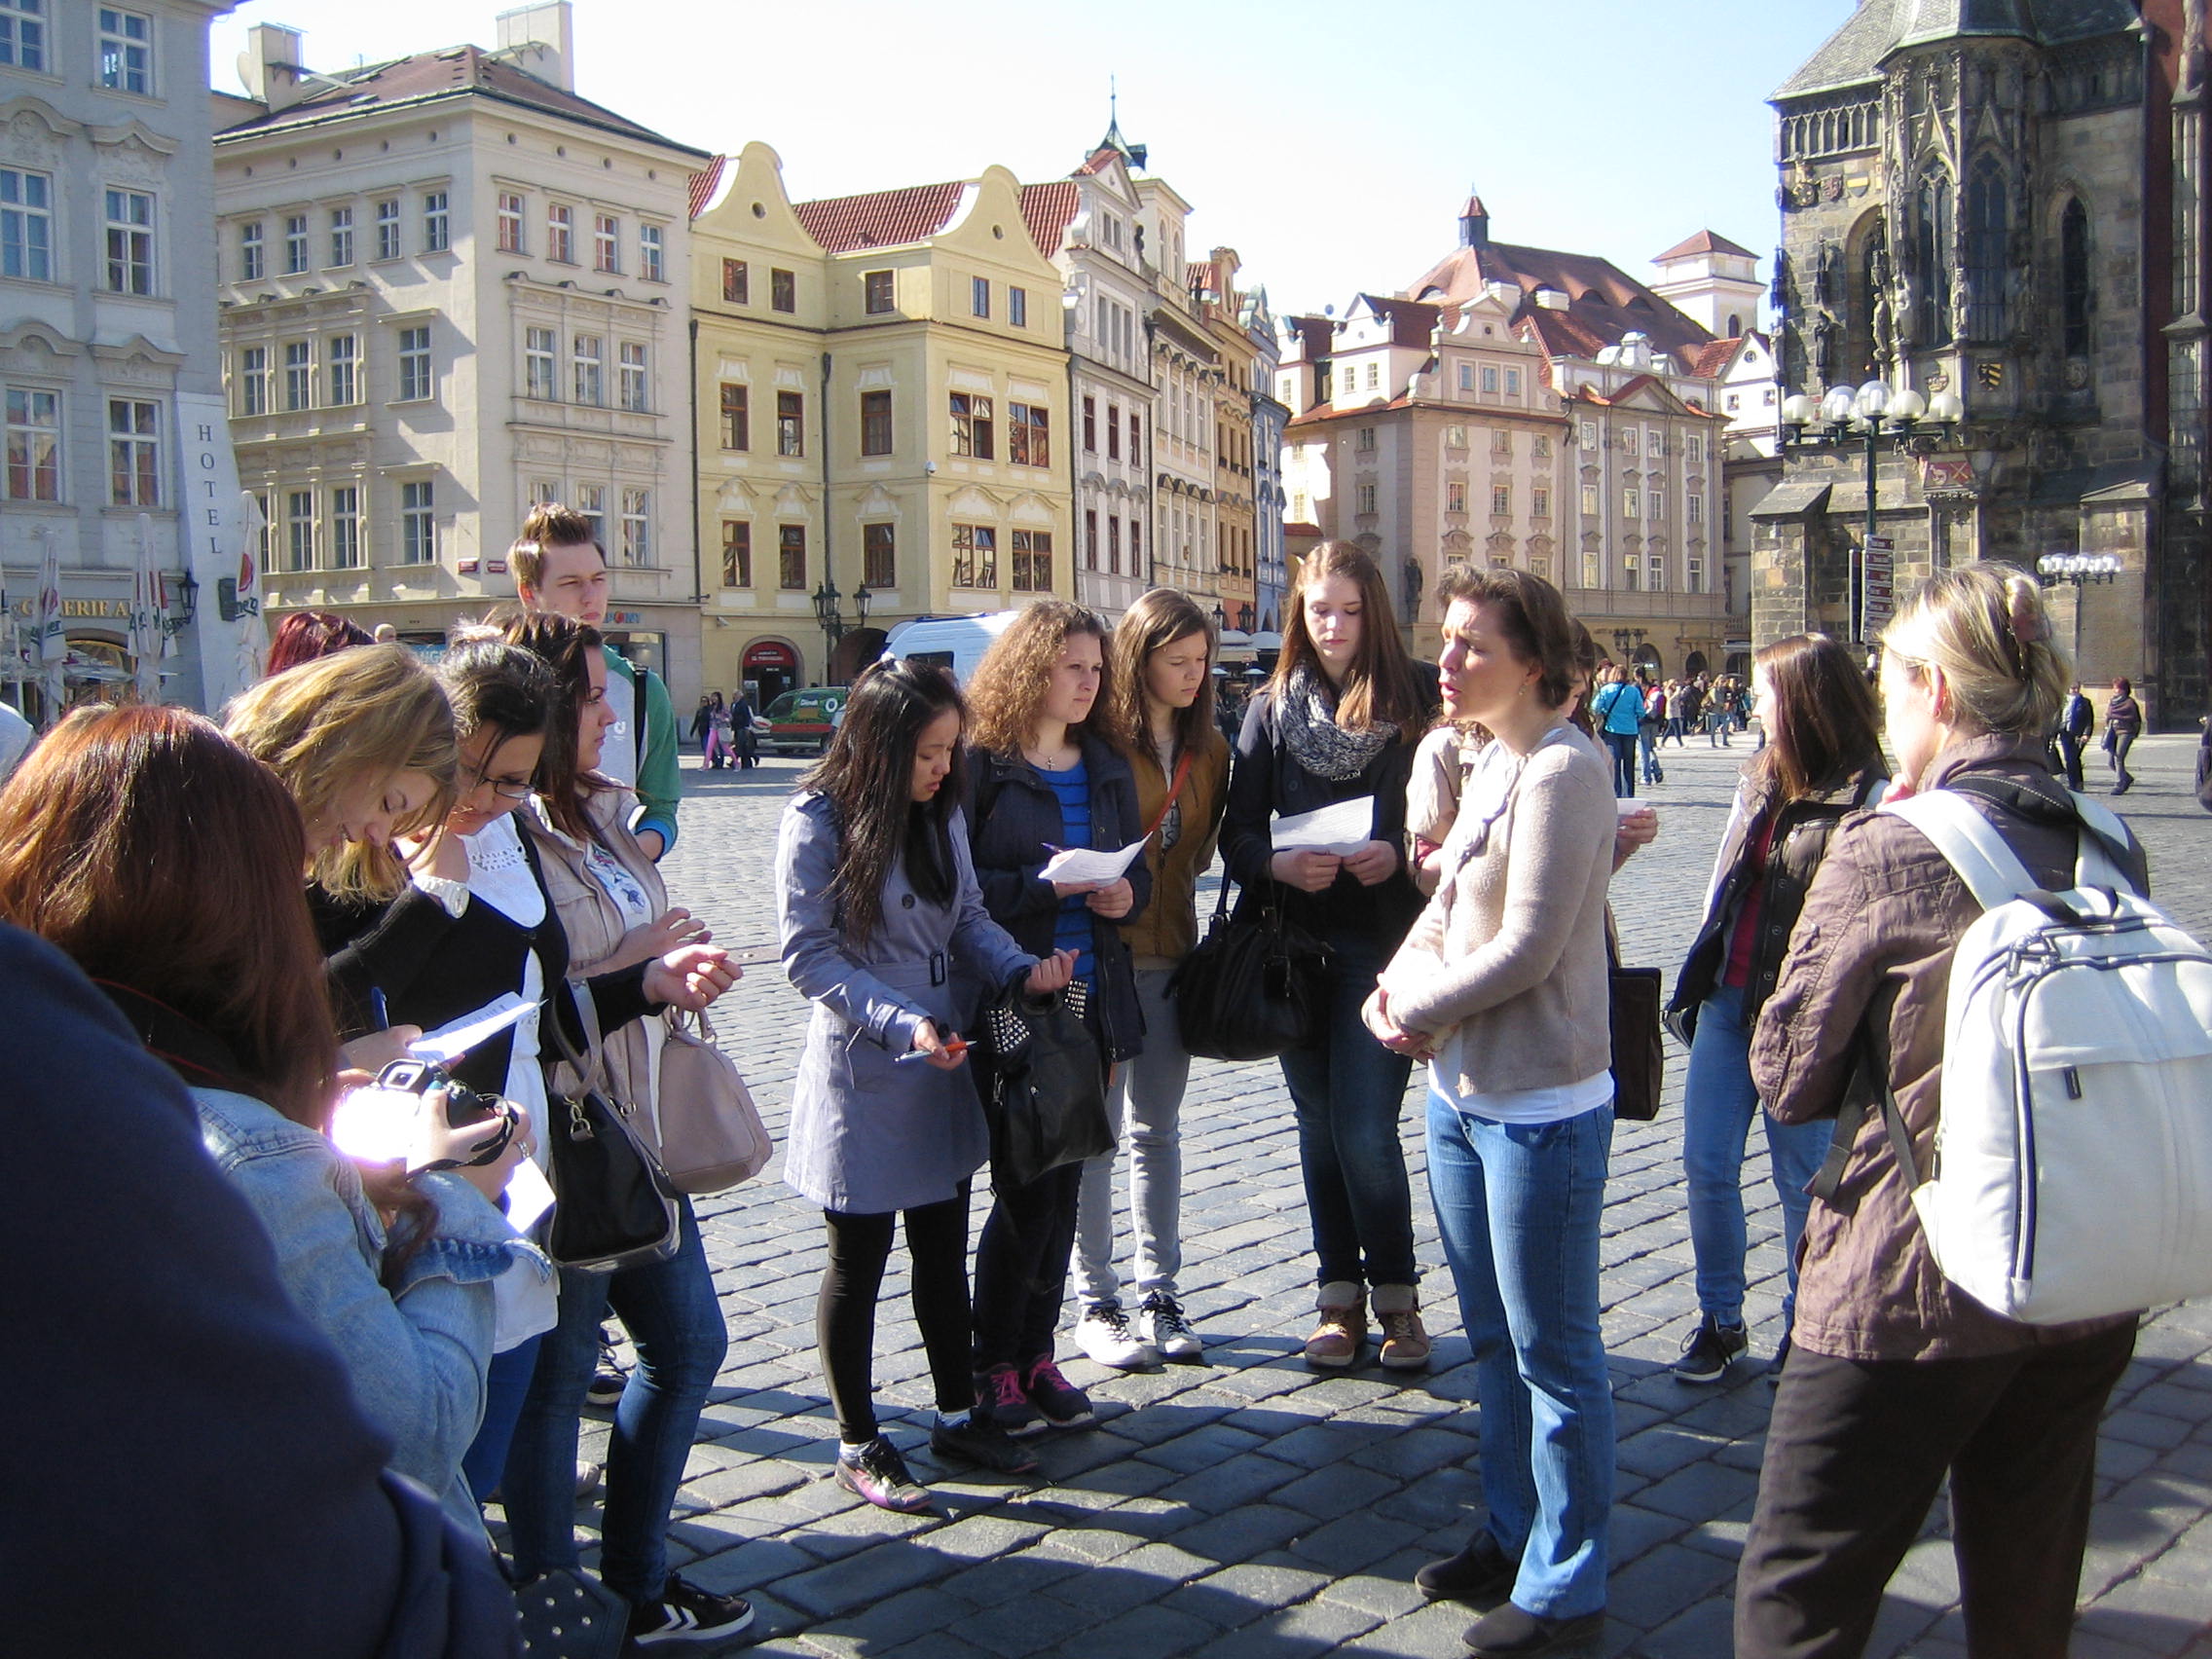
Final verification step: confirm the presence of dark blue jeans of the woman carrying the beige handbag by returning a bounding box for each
[502,1198,730,1602]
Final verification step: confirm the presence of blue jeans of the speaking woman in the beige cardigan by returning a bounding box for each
[1429,1090,1612,1619]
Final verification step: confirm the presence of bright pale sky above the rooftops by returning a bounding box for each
[212,0,1854,312]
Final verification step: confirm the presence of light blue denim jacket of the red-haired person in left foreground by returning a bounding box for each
[193,1088,553,1527]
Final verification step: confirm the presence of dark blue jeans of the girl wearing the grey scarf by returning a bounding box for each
[1283,940,1420,1285]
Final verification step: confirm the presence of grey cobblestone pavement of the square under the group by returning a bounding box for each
[501,739,2212,1659]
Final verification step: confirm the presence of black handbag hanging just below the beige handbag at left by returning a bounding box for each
[542,991,682,1274]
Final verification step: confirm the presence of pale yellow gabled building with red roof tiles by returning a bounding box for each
[692,144,1075,708]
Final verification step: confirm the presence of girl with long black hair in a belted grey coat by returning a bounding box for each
[776,661,1073,1511]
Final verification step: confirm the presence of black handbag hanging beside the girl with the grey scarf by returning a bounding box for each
[1168,880,1329,1059]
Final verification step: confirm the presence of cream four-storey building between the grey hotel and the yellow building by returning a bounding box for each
[214,0,708,703]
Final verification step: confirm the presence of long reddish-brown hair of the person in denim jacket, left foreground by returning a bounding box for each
[0,706,339,1128]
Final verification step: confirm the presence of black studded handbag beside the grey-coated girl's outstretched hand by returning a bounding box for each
[984,984,1115,1186]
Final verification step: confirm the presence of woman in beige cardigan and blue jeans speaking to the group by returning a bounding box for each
[1367,567,1615,1654]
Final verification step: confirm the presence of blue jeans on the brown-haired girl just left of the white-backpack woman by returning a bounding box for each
[1681,986,1836,1334]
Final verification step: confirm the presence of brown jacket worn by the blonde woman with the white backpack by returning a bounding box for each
[1751,734,2146,1360]
